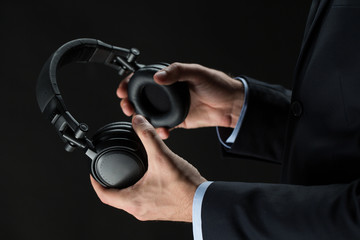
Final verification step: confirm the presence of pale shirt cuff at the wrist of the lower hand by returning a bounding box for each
[192,182,212,240]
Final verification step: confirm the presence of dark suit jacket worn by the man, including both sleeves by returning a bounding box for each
[202,0,360,240]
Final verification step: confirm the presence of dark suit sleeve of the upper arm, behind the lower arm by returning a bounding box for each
[219,76,291,163]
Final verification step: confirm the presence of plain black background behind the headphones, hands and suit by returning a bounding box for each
[0,0,310,240]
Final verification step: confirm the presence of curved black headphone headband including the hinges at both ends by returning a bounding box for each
[36,38,141,151]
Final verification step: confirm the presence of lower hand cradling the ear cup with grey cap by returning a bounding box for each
[91,115,206,222]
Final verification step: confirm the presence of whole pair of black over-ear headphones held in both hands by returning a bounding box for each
[36,38,190,188]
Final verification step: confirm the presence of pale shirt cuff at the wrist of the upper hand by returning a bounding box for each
[216,77,249,149]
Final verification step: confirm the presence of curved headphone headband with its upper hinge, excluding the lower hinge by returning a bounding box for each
[36,38,139,116]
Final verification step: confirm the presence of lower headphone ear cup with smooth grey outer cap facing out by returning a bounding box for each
[90,122,148,189]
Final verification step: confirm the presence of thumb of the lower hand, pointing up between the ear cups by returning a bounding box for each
[132,115,167,154]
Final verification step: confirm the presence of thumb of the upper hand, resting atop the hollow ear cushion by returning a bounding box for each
[154,63,206,85]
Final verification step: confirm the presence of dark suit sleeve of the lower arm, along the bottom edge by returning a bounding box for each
[201,181,360,240]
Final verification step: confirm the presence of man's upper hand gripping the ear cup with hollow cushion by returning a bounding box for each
[117,63,244,139]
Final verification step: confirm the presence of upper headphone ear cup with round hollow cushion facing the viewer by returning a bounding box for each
[128,64,190,128]
